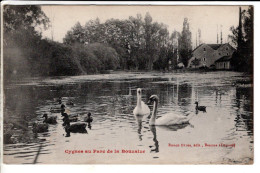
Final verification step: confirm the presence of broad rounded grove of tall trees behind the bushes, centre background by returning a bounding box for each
[64,13,179,70]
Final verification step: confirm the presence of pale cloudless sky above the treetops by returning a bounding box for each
[42,5,247,47]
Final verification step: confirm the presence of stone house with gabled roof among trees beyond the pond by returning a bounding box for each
[188,43,235,68]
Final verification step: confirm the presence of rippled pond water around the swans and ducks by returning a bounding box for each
[4,72,254,164]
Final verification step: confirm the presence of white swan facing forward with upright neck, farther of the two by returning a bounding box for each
[133,88,150,116]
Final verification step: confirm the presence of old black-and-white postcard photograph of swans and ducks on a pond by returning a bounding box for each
[1,4,254,165]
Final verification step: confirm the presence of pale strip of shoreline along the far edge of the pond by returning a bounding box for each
[5,71,253,88]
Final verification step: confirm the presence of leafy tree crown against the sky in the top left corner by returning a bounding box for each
[3,5,50,46]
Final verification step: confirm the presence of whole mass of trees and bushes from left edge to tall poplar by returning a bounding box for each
[4,5,198,76]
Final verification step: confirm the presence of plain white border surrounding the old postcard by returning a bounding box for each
[1,1,260,173]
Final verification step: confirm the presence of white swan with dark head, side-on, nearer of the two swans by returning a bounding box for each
[148,95,192,126]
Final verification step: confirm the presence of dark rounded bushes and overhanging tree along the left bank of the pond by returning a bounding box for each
[4,6,119,79]
